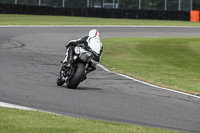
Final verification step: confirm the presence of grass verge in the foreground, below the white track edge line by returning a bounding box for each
[0,107,181,133]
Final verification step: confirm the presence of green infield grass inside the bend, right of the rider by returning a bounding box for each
[101,37,200,95]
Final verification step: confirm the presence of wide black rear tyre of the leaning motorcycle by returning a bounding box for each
[67,63,85,89]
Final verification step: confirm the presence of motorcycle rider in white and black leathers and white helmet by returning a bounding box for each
[63,29,103,72]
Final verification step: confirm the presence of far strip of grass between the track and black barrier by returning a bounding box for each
[0,14,200,26]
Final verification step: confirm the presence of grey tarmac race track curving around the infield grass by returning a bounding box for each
[0,27,200,132]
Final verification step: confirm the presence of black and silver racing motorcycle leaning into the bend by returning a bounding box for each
[57,43,96,89]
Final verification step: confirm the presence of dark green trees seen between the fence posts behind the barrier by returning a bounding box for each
[0,0,200,10]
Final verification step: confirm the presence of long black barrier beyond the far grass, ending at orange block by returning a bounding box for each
[0,4,190,21]
